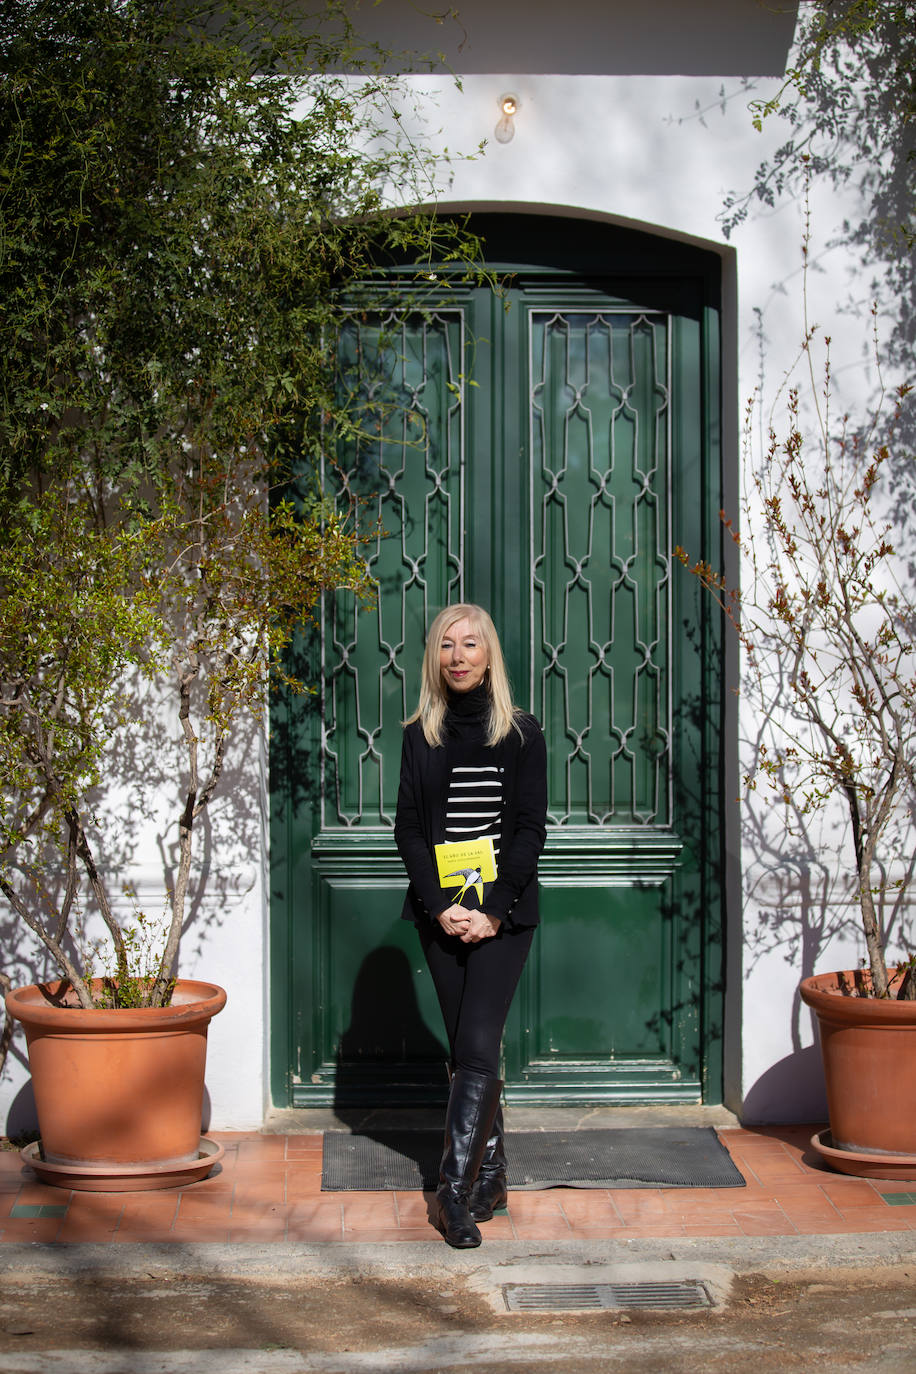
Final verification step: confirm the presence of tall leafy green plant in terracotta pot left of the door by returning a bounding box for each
[0,0,480,1189]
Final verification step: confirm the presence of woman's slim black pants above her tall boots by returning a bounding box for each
[419,921,534,1079]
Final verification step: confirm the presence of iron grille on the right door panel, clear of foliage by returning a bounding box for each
[530,311,670,826]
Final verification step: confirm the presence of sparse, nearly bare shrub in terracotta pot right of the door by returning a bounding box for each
[676,303,916,1178]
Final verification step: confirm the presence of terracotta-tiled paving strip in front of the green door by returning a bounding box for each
[0,1125,916,1246]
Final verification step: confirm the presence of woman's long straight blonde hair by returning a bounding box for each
[404,602,522,749]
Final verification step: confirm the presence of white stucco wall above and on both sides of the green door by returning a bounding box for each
[0,16,900,1129]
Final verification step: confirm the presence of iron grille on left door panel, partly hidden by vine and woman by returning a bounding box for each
[321,311,464,830]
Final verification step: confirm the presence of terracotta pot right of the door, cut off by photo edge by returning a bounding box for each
[799,970,916,1178]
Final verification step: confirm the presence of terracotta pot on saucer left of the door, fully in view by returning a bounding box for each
[7,980,225,1191]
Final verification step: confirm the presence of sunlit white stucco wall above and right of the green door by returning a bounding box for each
[390,64,900,1121]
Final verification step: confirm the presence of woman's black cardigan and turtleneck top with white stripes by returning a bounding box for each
[394,684,547,926]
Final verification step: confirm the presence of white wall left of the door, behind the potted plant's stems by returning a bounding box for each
[0,701,268,1135]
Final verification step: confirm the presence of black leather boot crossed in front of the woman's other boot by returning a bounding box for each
[435,1069,503,1250]
